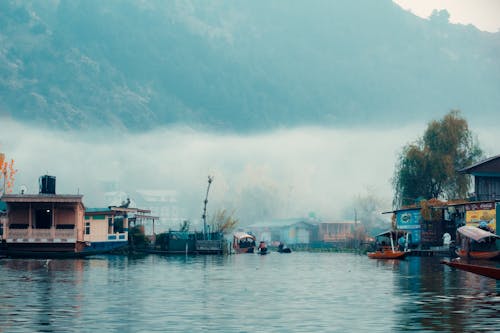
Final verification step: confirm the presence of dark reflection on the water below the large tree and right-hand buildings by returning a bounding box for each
[395,257,500,332]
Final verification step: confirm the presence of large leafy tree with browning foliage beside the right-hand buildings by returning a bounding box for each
[392,110,483,206]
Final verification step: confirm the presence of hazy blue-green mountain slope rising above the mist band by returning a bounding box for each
[0,0,500,131]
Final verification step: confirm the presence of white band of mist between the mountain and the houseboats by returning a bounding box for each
[1,120,498,224]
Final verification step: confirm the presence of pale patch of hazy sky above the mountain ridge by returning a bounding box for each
[393,0,500,32]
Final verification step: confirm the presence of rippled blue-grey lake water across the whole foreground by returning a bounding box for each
[0,252,500,332]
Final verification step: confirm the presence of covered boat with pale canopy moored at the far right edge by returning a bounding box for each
[456,225,500,259]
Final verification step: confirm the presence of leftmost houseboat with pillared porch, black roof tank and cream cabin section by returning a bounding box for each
[1,175,151,258]
